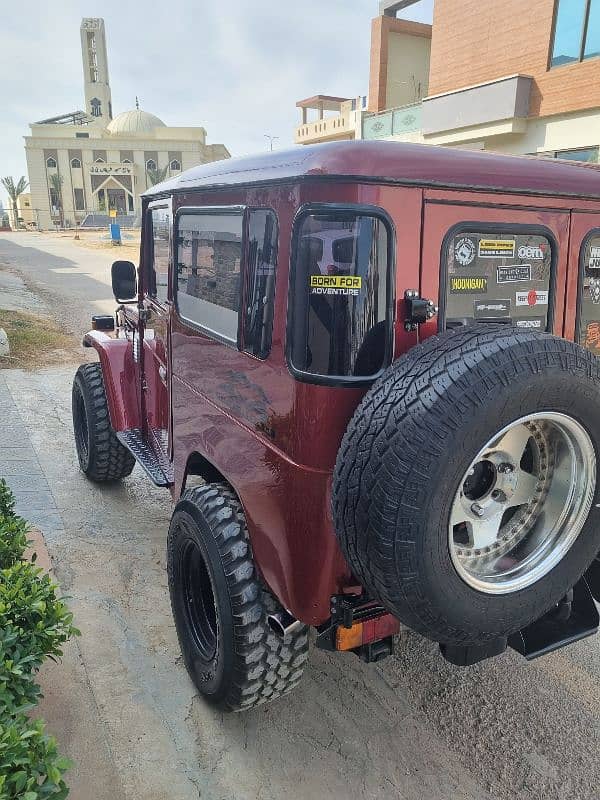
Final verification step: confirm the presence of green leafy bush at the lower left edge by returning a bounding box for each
[0,480,78,800]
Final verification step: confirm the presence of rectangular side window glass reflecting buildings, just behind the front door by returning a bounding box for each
[177,211,243,342]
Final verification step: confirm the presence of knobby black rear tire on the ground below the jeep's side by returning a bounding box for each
[167,483,308,711]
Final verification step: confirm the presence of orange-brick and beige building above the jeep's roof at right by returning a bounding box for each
[295,0,600,162]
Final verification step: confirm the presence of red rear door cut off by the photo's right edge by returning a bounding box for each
[565,211,600,355]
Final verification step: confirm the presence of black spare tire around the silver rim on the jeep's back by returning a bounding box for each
[333,324,600,645]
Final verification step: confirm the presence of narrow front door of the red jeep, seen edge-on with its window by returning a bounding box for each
[142,199,172,474]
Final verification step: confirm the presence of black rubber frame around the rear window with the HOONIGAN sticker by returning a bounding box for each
[438,221,558,333]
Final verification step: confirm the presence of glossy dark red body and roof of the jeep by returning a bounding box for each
[76,142,600,708]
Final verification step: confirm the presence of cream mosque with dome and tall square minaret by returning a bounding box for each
[25,18,229,228]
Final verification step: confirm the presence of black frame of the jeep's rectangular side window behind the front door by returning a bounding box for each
[172,205,251,346]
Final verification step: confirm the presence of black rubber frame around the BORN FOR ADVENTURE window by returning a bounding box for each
[285,203,396,388]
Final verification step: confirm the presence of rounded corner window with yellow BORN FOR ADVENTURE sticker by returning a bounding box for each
[288,207,392,383]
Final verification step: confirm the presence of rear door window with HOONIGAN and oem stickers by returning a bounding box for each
[441,226,552,330]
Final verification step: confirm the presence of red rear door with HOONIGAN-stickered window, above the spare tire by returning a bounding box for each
[421,200,569,337]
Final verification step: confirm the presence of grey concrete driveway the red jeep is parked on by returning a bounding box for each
[0,231,600,800]
